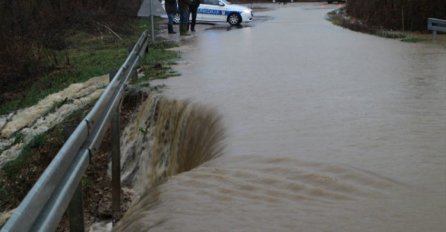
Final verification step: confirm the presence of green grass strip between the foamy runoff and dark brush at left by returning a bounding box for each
[0,19,176,115]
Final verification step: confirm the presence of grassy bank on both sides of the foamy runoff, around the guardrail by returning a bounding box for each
[0,19,179,229]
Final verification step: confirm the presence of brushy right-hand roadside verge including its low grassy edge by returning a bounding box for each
[328,0,446,43]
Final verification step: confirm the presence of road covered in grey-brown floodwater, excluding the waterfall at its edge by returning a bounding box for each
[123,3,446,231]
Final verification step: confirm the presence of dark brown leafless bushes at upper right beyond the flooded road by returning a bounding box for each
[347,0,446,31]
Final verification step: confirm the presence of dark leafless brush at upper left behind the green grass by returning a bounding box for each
[0,0,141,95]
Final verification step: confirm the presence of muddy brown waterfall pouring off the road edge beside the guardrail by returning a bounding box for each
[116,94,224,196]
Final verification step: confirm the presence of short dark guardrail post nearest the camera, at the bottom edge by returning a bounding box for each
[63,126,85,232]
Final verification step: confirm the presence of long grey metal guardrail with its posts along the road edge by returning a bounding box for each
[1,31,148,232]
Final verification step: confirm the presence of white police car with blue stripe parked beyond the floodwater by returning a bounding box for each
[161,0,253,25]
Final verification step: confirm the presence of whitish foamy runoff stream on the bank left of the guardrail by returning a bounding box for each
[0,75,108,166]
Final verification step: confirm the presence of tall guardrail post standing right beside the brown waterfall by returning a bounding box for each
[110,72,121,220]
